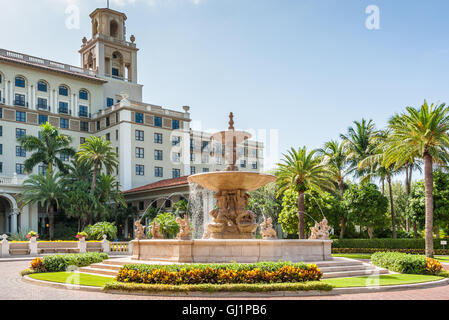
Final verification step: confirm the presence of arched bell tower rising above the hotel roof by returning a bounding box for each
[79,8,139,83]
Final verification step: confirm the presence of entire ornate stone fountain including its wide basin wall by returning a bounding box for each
[132,113,332,263]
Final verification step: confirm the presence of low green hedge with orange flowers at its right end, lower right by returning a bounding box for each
[371,252,443,275]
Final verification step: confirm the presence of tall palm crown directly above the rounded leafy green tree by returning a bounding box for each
[340,119,377,178]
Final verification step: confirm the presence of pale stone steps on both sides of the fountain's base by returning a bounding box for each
[79,258,389,279]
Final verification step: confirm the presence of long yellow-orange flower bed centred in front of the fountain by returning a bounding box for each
[116,262,323,285]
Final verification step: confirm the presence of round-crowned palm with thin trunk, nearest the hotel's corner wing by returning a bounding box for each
[77,136,118,194]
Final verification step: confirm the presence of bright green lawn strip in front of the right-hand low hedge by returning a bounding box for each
[322,274,443,288]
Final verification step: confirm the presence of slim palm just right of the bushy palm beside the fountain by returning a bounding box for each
[319,140,348,239]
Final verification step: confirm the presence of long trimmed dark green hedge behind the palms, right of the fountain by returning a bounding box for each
[332,239,448,249]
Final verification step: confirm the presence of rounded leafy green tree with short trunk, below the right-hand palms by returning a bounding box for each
[344,183,388,238]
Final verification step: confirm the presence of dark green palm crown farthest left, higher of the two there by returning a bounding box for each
[17,122,76,172]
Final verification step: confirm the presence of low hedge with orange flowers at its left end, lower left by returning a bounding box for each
[31,252,109,272]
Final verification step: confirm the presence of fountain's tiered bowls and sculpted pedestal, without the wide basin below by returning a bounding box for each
[187,112,276,239]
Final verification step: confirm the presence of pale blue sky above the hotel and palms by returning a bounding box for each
[0,0,449,171]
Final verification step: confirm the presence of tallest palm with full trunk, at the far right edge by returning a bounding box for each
[385,101,449,257]
